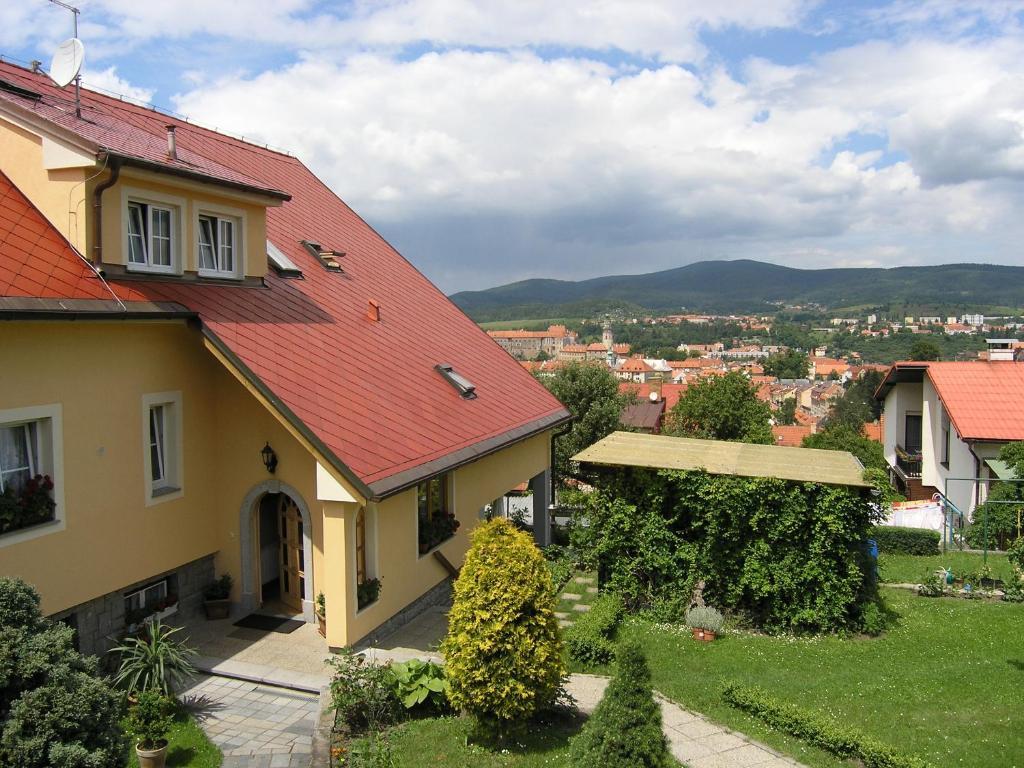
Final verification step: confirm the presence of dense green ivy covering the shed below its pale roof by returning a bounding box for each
[573,469,878,632]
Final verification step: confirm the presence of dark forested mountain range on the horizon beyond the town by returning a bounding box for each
[452,259,1024,321]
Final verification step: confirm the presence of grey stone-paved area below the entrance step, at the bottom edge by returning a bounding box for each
[180,675,319,768]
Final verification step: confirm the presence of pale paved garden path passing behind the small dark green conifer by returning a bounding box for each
[566,675,804,768]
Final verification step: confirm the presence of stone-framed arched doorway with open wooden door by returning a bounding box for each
[239,480,314,622]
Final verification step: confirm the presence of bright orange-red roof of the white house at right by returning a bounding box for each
[874,360,1024,442]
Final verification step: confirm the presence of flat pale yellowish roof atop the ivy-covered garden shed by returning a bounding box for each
[572,432,870,487]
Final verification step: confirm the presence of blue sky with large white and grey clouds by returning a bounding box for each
[6,0,1024,292]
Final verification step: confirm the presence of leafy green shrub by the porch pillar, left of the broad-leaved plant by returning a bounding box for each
[328,648,399,733]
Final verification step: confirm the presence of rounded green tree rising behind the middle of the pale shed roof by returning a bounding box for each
[665,372,774,444]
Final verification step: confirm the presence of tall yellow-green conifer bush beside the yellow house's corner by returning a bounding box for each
[441,518,564,735]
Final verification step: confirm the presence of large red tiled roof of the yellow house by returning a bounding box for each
[0,62,568,498]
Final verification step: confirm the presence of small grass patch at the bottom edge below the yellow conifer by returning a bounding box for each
[353,716,583,768]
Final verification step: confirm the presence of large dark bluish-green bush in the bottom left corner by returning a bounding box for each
[0,578,127,768]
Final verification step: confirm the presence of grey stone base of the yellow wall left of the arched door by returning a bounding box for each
[51,555,214,655]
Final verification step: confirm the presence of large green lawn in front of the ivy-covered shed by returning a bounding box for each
[606,589,1024,768]
